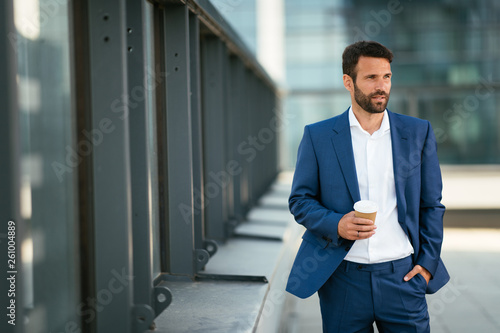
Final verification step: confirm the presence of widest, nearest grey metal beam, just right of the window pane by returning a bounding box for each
[88,0,133,332]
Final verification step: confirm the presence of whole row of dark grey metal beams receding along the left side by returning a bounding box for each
[0,0,279,332]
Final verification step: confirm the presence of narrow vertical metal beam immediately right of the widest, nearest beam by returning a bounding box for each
[126,0,158,326]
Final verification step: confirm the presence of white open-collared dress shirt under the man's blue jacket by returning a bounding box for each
[345,107,413,264]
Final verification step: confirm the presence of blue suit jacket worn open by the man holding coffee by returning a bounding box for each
[286,111,450,298]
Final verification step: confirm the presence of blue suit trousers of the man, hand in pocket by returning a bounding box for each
[318,256,430,333]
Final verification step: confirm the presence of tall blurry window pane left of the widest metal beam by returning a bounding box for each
[14,0,80,332]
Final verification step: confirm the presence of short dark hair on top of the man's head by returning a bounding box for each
[342,40,393,82]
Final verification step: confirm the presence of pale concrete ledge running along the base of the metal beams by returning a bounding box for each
[151,181,304,333]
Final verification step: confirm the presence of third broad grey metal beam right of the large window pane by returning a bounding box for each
[201,35,227,241]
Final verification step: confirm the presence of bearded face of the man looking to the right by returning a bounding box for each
[353,57,392,113]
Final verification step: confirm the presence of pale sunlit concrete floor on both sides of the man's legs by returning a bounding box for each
[286,228,500,333]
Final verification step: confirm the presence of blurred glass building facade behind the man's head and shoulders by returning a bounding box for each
[217,0,500,168]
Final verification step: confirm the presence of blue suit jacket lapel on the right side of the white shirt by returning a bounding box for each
[387,110,410,226]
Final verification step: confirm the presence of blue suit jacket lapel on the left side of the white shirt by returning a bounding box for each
[332,110,361,202]
